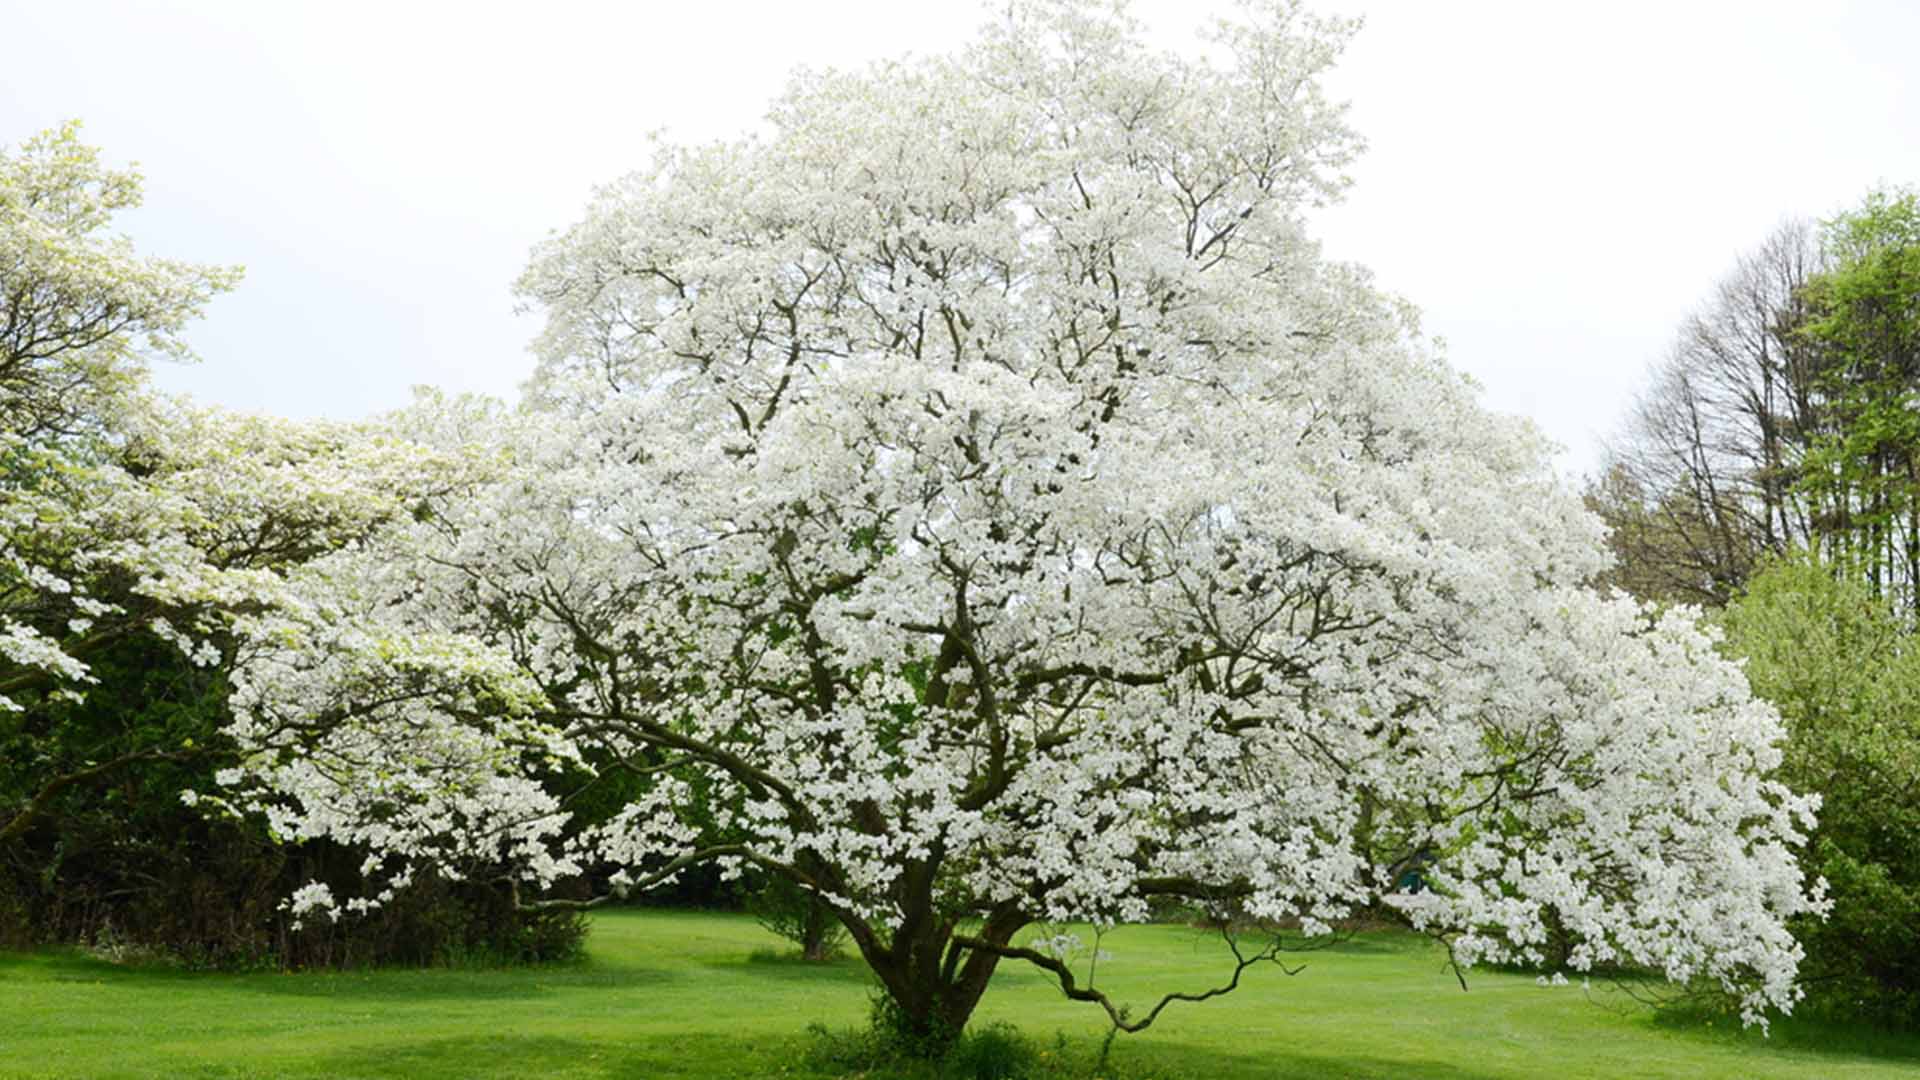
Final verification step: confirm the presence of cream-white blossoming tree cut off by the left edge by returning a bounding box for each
[0,125,476,844]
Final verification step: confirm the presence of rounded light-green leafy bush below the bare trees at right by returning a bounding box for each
[1724,555,1920,1024]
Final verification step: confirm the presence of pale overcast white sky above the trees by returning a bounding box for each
[0,0,1920,473]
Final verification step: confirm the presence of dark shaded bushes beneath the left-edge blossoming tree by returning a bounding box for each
[0,634,586,967]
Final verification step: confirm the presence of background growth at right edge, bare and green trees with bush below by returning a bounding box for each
[1588,188,1920,1024]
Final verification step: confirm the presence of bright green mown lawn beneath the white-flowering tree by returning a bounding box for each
[0,911,1920,1080]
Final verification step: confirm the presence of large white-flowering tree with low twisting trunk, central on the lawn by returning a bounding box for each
[220,4,1816,1032]
